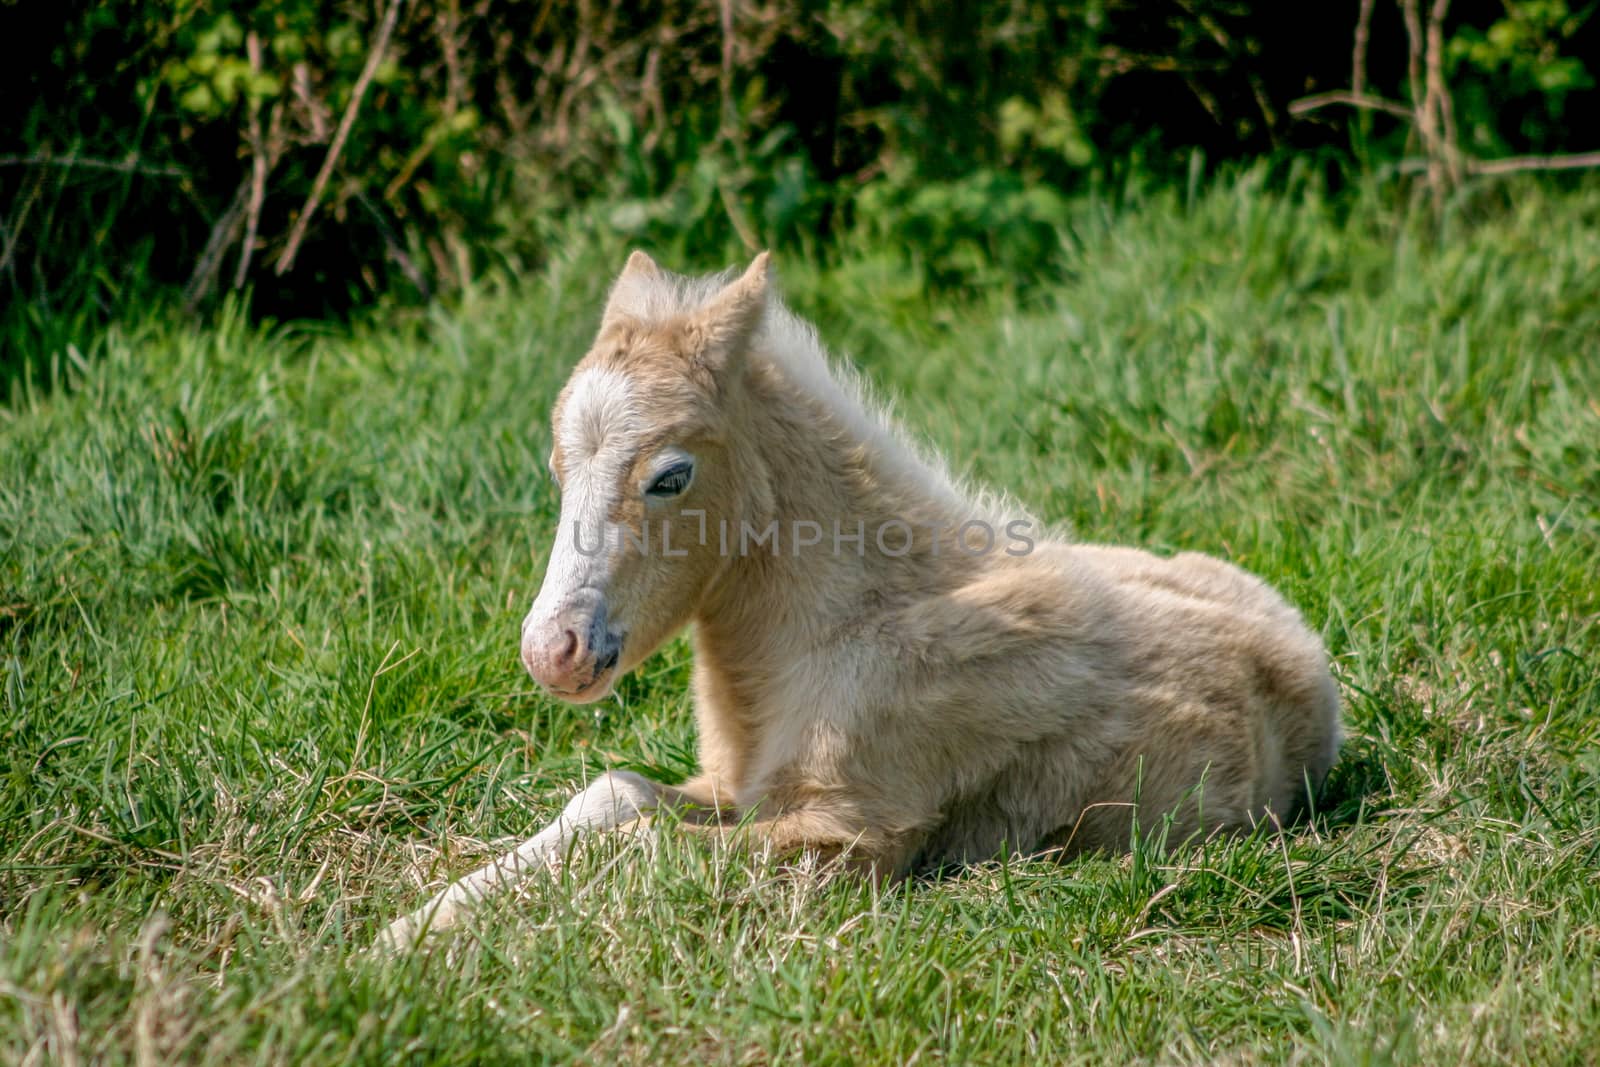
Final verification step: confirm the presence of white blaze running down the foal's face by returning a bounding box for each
[523,368,640,633]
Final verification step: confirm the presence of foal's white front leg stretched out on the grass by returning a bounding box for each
[374,771,675,952]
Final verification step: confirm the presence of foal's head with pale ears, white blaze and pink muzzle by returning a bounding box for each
[522,253,766,702]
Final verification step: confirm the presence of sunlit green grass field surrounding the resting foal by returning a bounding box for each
[0,178,1600,1065]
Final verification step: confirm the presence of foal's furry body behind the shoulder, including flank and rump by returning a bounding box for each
[917,544,1339,864]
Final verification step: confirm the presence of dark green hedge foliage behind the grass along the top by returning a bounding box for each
[0,0,1600,358]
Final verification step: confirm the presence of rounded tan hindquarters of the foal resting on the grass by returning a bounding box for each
[1058,545,1339,848]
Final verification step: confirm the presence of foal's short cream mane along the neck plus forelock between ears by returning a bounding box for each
[611,262,1027,518]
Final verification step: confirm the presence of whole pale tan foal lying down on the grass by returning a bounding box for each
[384,253,1339,945]
